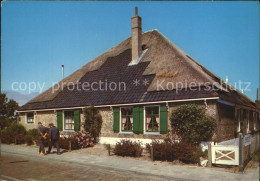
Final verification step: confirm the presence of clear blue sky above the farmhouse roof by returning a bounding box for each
[1,1,260,103]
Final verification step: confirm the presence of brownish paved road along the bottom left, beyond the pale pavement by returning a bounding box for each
[1,153,169,181]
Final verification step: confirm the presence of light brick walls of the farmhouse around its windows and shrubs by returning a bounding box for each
[19,100,239,142]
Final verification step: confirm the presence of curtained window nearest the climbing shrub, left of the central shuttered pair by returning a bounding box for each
[121,107,133,132]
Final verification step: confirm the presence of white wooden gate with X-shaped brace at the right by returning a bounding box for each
[211,145,239,165]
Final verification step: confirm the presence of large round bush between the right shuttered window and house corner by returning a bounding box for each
[170,104,216,144]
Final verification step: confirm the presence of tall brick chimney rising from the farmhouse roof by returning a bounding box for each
[131,7,142,60]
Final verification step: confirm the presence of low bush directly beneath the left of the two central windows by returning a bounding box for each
[113,139,143,157]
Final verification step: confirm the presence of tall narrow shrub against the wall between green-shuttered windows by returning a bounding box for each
[84,107,102,141]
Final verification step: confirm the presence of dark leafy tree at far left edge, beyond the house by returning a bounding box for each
[0,93,19,129]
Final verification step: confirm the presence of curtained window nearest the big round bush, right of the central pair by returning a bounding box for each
[145,106,160,132]
